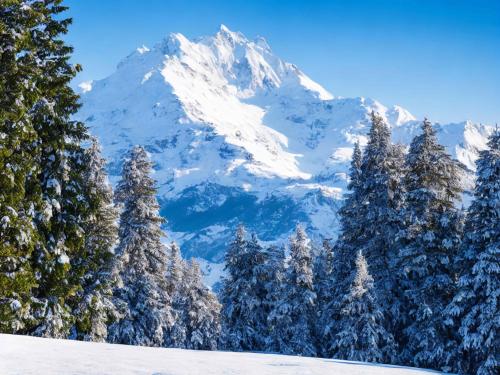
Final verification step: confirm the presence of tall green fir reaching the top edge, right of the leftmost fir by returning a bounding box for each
[23,0,91,337]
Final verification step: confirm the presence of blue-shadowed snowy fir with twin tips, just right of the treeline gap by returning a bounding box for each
[221,226,268,351]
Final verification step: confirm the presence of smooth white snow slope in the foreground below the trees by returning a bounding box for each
[0,335,435,375]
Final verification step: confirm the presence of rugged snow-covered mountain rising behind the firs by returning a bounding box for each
[78,26,492,274]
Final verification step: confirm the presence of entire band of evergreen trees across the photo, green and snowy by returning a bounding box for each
[0,0,500,374]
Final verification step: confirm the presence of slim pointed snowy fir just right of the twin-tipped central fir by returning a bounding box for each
[274,225,317,356]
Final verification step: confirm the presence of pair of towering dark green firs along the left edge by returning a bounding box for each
[0,0,93,337]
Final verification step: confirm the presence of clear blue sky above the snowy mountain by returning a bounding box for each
[66,0,500,123]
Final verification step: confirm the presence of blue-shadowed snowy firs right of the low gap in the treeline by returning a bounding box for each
[220,113,500,374]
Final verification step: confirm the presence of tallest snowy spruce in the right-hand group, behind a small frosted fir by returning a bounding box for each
[322,112,402,362]
